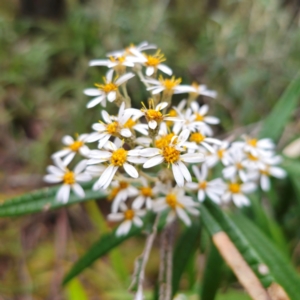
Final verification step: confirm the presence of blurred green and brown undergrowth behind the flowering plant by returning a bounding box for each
[0,0,300,300]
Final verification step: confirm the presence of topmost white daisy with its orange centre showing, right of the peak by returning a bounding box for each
[129,50,173,76]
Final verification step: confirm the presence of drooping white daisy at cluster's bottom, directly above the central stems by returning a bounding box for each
[153,188,199,226]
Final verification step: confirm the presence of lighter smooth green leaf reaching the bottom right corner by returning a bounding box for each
[232,214,300,300]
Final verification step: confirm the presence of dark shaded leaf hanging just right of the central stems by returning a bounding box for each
[172,222,200,295]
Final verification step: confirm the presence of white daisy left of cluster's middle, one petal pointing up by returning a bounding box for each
[87,102,132,149]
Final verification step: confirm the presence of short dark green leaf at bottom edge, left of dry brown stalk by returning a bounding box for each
[200,244,224,300]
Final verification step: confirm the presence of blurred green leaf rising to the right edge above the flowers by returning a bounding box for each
[259,73,300,141]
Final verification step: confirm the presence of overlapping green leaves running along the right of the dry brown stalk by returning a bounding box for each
[201,201,300,300]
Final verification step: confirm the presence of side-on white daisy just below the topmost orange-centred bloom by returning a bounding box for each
[143,76,189,98]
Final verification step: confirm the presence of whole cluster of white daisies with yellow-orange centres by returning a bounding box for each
[44,42,285,239]
